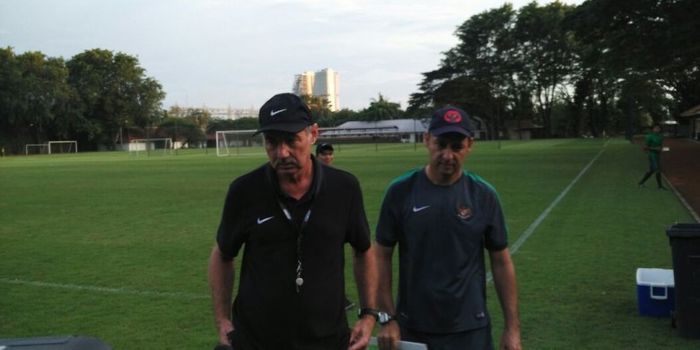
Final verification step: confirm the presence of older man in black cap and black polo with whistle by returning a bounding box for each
[209,93,376,350]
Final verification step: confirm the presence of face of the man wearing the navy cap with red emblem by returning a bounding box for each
[424,133,474,178]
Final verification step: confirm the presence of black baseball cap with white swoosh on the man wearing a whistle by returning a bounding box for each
[255,93,313,134]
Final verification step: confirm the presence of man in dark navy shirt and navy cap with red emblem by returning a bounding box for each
[375,106,521,350]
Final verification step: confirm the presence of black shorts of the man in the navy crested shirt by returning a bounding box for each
[401,324,493,350]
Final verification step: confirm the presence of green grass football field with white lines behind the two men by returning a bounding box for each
[0,139,700,349]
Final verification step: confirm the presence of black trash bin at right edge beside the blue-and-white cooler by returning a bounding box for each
[666,224,700,339]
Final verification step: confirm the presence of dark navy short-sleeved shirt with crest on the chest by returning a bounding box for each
[376,169,508,333]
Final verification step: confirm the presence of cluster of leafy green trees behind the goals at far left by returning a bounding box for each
[0,47,165,153]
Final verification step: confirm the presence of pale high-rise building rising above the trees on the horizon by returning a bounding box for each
[292,68,340,112]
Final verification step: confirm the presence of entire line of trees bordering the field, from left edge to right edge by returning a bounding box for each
[0,0,700,153]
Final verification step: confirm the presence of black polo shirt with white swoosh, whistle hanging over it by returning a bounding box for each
[217,157,370,349]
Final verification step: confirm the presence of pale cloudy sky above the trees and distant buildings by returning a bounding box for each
[0,0,582,110]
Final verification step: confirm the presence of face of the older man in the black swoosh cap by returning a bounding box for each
[265,124,318,176]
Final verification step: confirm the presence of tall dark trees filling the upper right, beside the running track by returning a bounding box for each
[408,0,700,138]
